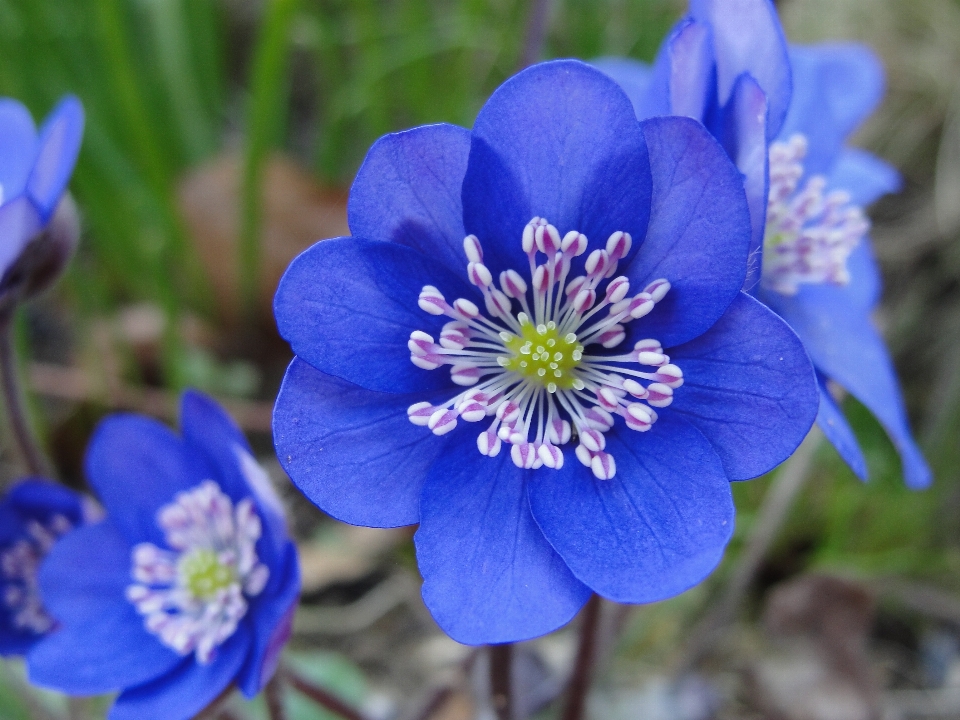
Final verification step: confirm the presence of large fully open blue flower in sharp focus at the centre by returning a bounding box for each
[274,61,818,644]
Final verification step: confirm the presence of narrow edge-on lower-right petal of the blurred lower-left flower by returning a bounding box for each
[237,543,300,697]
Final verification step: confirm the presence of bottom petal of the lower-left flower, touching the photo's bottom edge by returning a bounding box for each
[107,624,250,720]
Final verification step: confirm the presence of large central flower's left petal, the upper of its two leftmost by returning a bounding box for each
[274,236,476,393]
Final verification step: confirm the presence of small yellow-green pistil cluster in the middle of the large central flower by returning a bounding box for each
[501,320,583,393]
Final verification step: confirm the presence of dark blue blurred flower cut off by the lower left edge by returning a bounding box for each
[0,479,89,655]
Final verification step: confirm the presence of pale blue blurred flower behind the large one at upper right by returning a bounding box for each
[597,0,931,488]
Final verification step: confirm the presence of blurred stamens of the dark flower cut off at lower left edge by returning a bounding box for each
[0,515,73,635]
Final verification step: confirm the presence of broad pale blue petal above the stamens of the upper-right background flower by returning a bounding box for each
[780,44,884,175]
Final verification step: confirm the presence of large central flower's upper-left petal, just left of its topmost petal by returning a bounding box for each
[347,125,470,274]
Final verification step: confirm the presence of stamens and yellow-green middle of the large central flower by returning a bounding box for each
[407,218,683,479]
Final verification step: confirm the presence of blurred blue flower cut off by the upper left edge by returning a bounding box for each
[0,96,84,295]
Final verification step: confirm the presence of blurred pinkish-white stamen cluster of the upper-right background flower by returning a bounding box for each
[762,134,870,295]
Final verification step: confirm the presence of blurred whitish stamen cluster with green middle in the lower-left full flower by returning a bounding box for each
[127,480,270,664]
